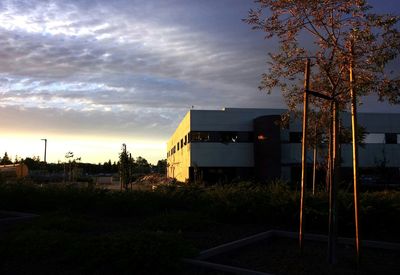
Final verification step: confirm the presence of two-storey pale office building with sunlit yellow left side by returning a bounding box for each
[167,108,400,182]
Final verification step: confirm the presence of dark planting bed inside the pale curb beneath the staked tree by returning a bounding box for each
[207,238,400,275]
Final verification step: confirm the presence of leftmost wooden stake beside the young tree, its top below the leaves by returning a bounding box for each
[299,58,310,251]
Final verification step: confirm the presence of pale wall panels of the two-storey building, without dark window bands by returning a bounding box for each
[167,108,400,184]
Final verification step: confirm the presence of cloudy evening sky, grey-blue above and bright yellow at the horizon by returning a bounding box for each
[0,0,400,164]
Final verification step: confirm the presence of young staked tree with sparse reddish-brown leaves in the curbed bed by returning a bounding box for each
[245,0,400,266]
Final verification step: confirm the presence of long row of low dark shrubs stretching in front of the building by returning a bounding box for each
[0,182,400,242]
